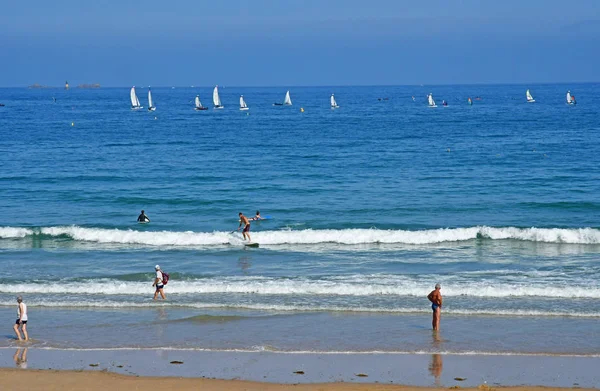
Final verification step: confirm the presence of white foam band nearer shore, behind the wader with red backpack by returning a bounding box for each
[0,275,600,299]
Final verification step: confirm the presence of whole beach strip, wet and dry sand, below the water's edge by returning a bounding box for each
[0,347,600,390]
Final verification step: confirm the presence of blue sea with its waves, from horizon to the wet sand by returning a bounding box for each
[0,84,600,355]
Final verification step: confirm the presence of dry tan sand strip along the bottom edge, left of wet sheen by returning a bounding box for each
[0,369,591,391]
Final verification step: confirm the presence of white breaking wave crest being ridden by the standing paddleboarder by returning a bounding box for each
[0,226,600,246]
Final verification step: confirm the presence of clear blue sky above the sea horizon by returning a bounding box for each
[0,0,600,87]
